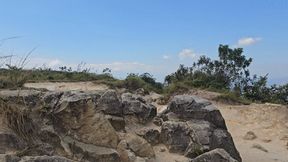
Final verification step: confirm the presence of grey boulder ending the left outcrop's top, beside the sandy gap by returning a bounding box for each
[121,93,157,123]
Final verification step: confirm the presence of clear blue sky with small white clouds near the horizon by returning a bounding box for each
[0,0,288,83]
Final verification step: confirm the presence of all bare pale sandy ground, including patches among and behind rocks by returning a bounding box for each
[25,82,288,162]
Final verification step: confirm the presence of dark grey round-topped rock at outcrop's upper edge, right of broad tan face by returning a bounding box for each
[96,90,123,116]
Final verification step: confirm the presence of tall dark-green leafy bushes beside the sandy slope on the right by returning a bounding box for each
[165,45,288,104]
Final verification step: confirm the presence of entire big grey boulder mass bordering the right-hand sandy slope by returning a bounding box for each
[159,95,242,162]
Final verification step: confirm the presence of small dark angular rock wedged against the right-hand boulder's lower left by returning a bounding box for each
[136,128,160,145]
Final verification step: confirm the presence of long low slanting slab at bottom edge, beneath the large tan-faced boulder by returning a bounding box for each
[62,136,120,162]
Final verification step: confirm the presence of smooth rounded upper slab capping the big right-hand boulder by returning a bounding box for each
[166,95,227,129]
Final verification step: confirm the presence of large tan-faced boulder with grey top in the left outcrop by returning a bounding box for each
[46,91,118,148]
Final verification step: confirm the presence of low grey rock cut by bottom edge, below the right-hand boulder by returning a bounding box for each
[190,149,238,162]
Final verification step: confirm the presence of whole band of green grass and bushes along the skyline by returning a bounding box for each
[0,45,288,104]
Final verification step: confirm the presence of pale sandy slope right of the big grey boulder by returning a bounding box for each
[216,104,288,162]
